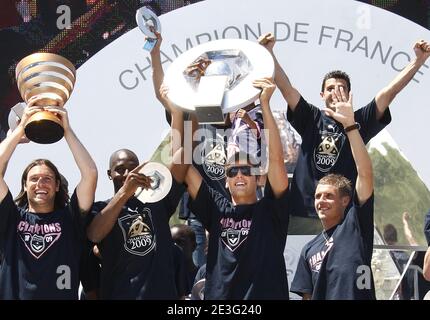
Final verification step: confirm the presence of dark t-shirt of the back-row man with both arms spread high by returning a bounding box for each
[287,97,391,217]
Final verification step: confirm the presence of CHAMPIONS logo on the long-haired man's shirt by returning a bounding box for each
[17,221,61,259]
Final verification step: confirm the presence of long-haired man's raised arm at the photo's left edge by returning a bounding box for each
[0,105,43,202]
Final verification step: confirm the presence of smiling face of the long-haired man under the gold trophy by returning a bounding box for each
[24,165,60,212]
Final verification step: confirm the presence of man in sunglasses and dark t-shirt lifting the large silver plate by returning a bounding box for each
[185,78,288,300]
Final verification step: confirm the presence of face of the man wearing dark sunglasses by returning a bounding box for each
[226,162,257,202]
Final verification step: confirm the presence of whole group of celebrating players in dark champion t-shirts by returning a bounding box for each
[0,28,430,300]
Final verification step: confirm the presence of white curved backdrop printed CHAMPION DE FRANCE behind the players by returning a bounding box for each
[6,0,430,199]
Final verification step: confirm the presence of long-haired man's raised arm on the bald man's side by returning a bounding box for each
[44,107,97,212]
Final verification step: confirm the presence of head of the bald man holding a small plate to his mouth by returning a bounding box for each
[108,151,139,192]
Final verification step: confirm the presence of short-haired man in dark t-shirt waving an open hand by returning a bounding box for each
[291,85,375,300]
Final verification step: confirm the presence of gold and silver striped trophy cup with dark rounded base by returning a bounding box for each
[15,53,76,144]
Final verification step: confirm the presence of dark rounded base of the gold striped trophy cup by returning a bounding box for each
[25,111,64,144]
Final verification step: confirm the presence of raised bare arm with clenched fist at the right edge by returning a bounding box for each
[375,40,430,120]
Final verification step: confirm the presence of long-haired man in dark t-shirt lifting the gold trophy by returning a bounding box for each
[0,104,97,300]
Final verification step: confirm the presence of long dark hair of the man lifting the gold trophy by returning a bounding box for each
[15,159,69,210]
